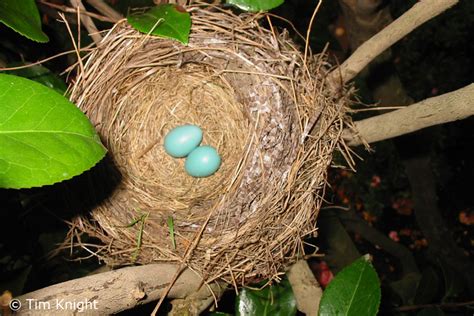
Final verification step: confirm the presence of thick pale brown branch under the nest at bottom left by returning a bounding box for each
[17,263,221,315]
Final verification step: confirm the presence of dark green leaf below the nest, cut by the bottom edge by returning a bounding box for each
[235,279,296,316]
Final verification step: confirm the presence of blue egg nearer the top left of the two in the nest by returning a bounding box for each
[164,125,202,158]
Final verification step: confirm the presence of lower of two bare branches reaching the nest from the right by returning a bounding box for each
[343,84,474,146]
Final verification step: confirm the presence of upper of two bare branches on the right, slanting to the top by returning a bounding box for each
[329,0,459,84]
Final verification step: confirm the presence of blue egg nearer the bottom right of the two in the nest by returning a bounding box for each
[184,146,221,178]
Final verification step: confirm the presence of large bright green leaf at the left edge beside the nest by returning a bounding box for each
[0,74,106,188]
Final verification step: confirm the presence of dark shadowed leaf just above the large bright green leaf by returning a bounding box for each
[6,64,67,95]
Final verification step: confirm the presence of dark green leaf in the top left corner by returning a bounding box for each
[0,0,49,43]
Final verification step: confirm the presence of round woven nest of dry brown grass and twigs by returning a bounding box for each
[71,5,348,285]
